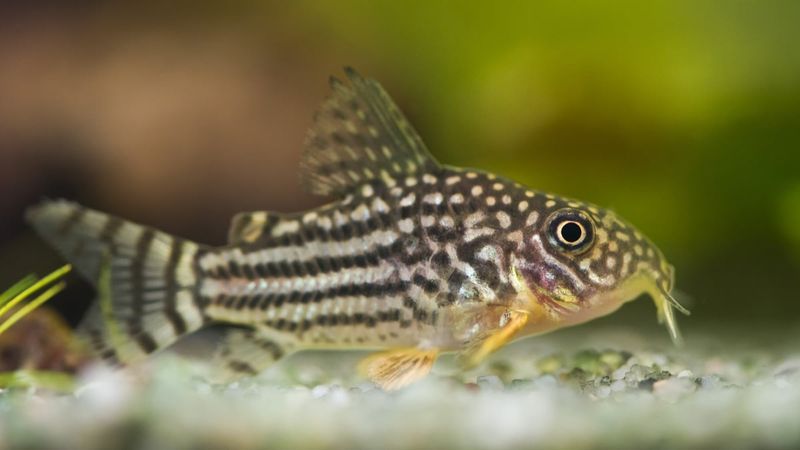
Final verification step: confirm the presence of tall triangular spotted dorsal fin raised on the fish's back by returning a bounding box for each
[300,67,440,195]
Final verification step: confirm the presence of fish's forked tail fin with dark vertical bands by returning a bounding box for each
[27,200,204,363]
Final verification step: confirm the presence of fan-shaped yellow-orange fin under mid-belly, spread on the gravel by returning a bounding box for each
[359,348,439,391]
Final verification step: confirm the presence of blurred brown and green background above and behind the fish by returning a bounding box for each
[0,0,800,329]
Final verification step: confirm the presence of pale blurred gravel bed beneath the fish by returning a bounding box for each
[0,330,800,449]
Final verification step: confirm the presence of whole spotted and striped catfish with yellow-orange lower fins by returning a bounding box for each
[27,68,688,390]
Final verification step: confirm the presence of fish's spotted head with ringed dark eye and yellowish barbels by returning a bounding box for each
[512,199,688,343]
